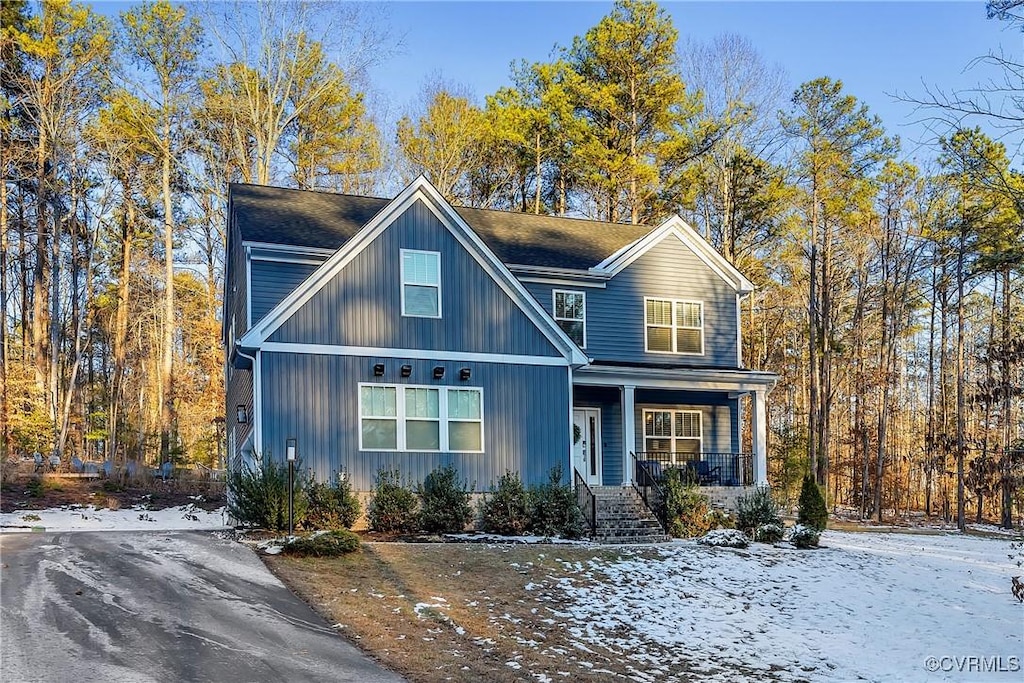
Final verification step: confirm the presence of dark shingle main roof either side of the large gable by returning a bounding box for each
[229,183,652,269]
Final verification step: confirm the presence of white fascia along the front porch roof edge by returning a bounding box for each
[572,366,778,393]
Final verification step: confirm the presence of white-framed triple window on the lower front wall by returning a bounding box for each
[359,384,483,453]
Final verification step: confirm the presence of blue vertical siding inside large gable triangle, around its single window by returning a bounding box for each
[270,201,560,356]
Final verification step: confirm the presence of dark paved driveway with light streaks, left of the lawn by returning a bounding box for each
[0,531,401,683]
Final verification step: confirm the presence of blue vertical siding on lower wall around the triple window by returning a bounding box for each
[261,351,570,490]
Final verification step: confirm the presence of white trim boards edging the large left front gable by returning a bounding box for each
[239,175,589,366]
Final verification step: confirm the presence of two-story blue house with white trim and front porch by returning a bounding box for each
[223,178,775,524]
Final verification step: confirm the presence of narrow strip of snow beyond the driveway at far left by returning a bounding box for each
[0,505,227,532]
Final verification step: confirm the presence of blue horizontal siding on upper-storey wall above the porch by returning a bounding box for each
[525,236,736,368]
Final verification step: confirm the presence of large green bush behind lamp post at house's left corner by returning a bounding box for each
[227,455,306,531]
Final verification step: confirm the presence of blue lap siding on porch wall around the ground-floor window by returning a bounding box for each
[636,389,739,453]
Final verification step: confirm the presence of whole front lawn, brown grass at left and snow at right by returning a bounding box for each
[267,531,1024,681]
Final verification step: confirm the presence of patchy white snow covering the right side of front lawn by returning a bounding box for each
[547,531,1024,681]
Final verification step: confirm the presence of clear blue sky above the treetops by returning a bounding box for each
[372,0,1024,157]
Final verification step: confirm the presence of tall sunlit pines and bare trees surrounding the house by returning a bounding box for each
[0,0,1024,525]
